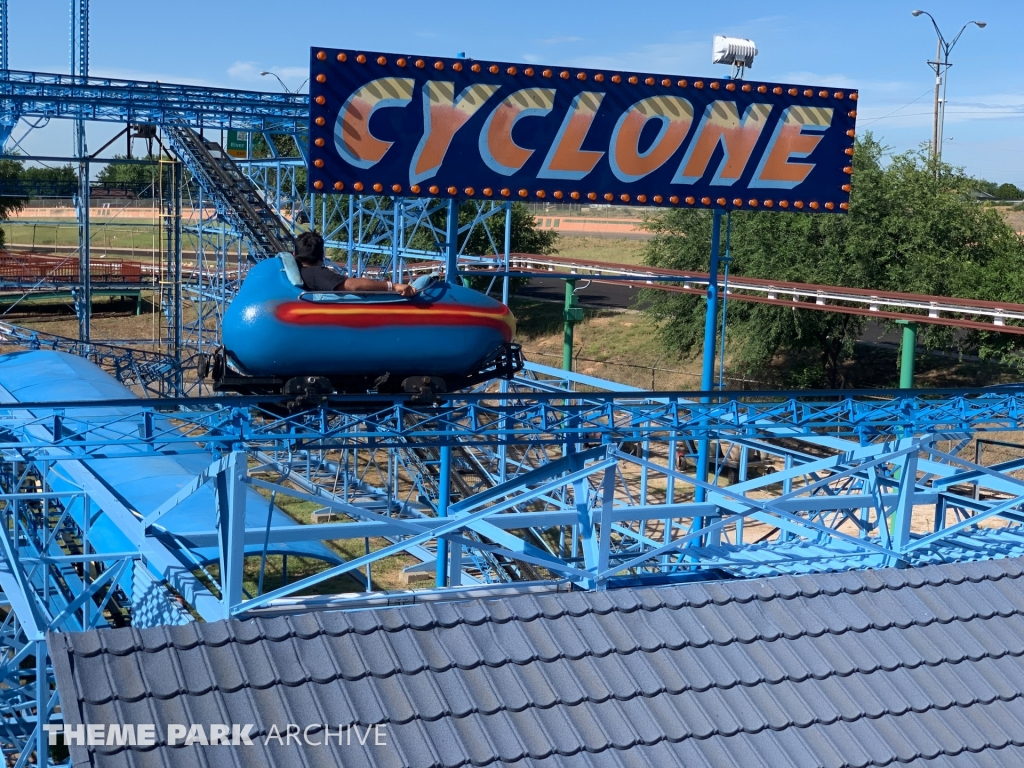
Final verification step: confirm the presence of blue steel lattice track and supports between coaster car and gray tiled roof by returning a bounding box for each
[0,366,1024,764]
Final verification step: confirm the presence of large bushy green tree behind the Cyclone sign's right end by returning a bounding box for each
[645,134,1024,387]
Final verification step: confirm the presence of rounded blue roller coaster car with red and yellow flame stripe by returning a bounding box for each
[208,253,522,406]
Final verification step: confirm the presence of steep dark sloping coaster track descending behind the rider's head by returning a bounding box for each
[164,126,293,261]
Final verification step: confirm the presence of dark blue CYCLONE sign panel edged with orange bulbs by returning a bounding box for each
[309,48,857,213]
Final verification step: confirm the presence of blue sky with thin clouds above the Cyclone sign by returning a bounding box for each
[9,0,1024,186]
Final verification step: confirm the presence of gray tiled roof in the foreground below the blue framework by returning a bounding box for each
[49,559,1024,768]
